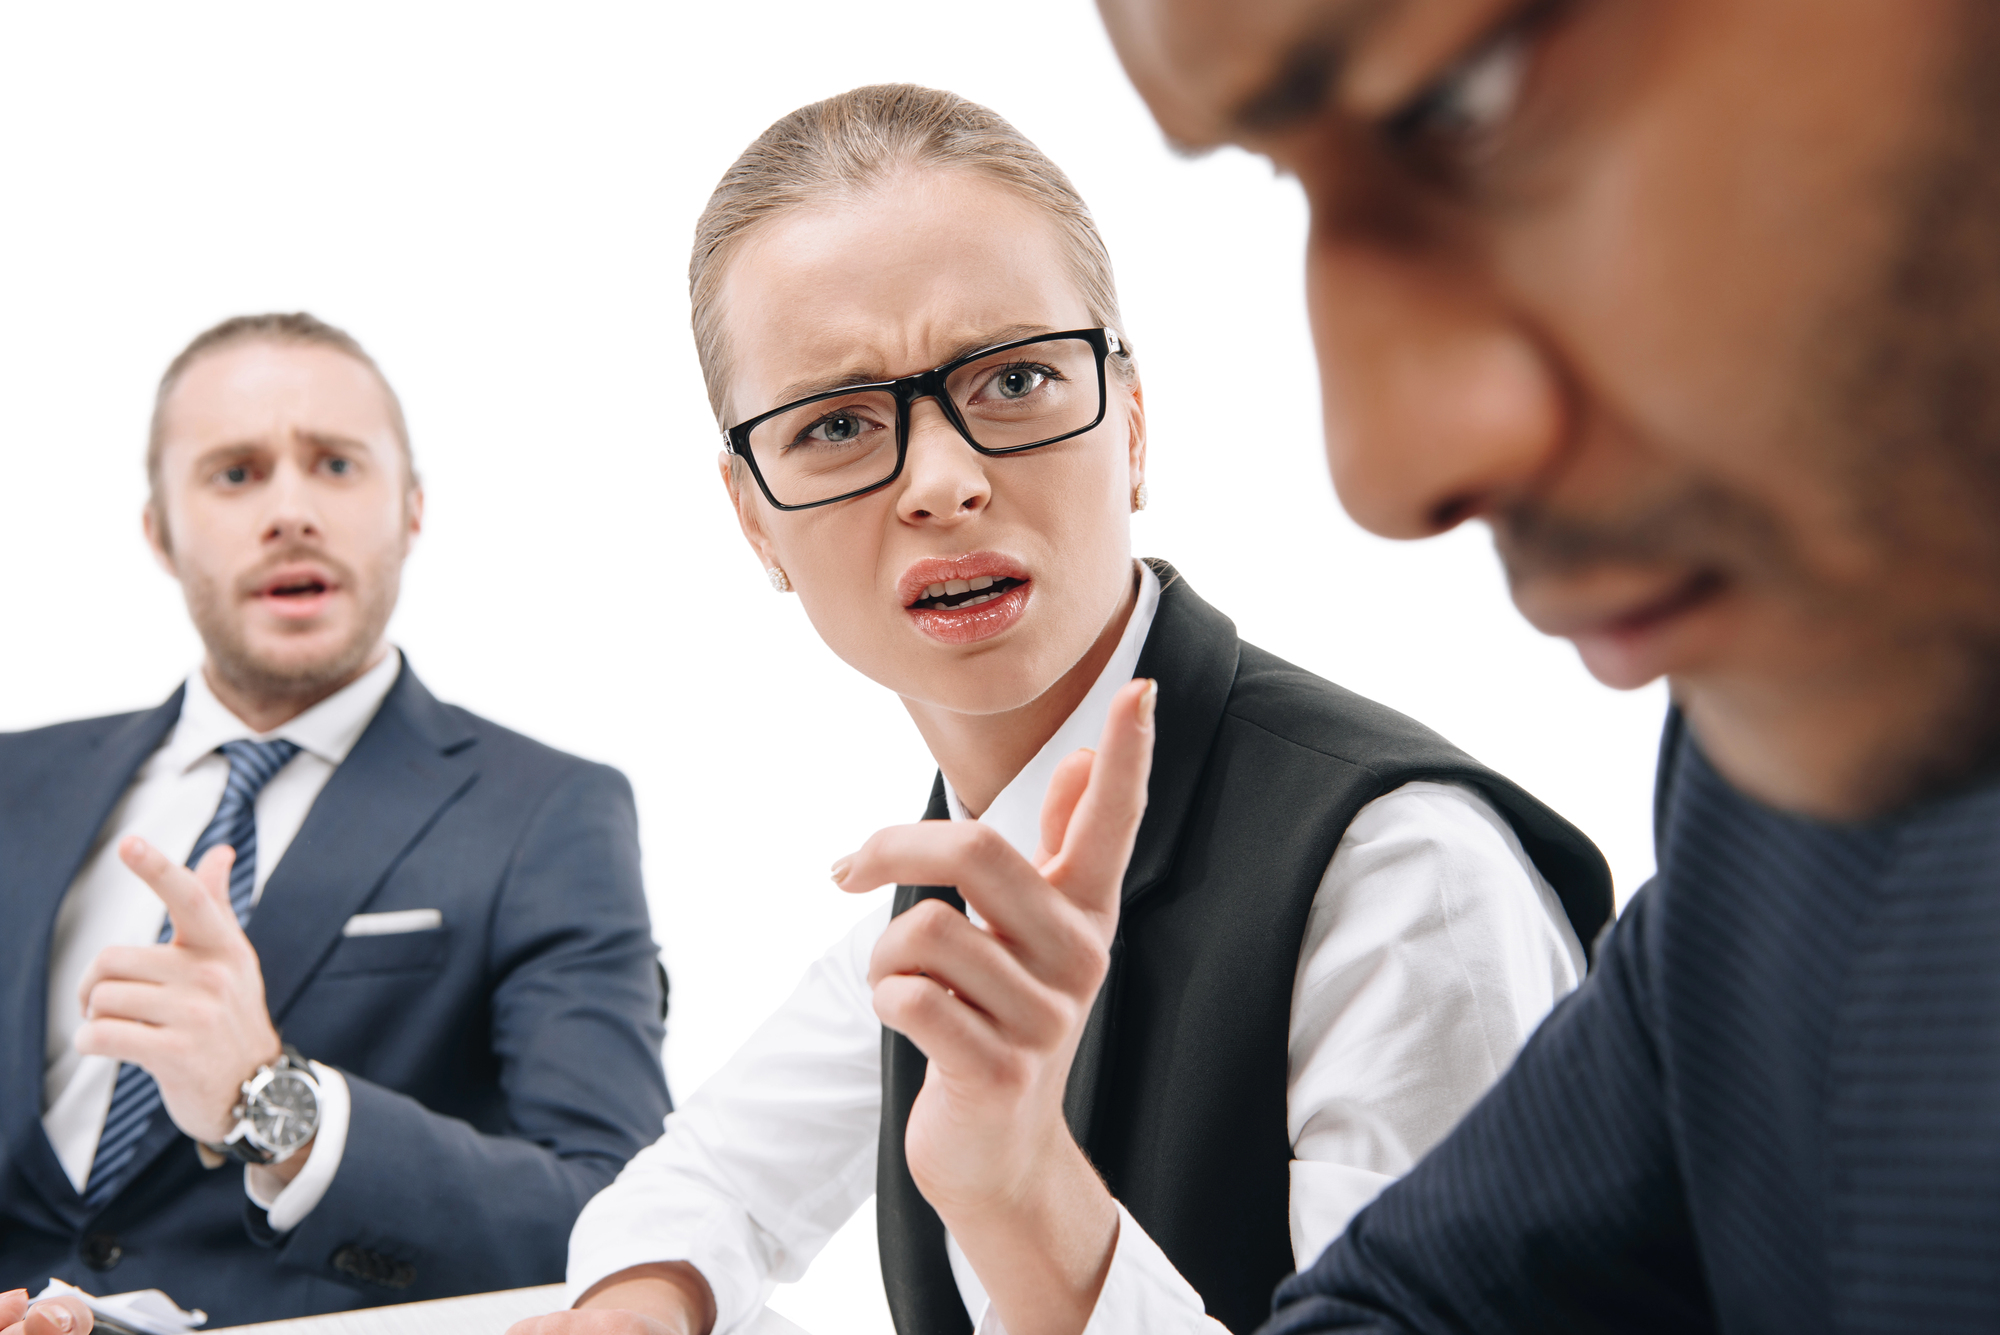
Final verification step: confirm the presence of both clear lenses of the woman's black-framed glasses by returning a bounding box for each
[750,338,1104,506]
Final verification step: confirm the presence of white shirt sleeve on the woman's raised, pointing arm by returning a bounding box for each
[978,781,1584,1335]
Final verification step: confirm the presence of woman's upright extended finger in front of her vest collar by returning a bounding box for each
[1042,677,1160,913]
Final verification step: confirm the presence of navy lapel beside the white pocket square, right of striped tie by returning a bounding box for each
[250,666,478,1025]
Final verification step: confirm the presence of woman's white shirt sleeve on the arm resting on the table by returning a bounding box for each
[566,903,890,1335]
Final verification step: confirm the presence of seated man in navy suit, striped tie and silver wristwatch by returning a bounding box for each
[0,316,668,1335]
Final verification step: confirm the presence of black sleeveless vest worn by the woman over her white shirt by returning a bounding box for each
[876,562,1612,1335]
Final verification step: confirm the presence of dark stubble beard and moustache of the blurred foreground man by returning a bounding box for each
[1492,4,2000,811]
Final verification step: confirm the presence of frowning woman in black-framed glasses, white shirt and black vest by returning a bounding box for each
[538,86,1610,1335]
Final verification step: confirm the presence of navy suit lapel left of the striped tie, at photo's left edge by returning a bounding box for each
[0,689,182,1223]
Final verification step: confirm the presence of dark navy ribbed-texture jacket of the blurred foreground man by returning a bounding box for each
[1266,723,2000,1335]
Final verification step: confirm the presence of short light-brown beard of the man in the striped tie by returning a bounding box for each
[186,550,402,707]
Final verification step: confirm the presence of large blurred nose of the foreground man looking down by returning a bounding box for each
[1306,236,1564,538]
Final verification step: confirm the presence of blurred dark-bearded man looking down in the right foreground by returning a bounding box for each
[1104,0,2000,1331]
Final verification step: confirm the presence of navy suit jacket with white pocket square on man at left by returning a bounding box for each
[0,666,670,1327]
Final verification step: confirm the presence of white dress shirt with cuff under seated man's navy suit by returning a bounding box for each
[42,650,402,1233]
